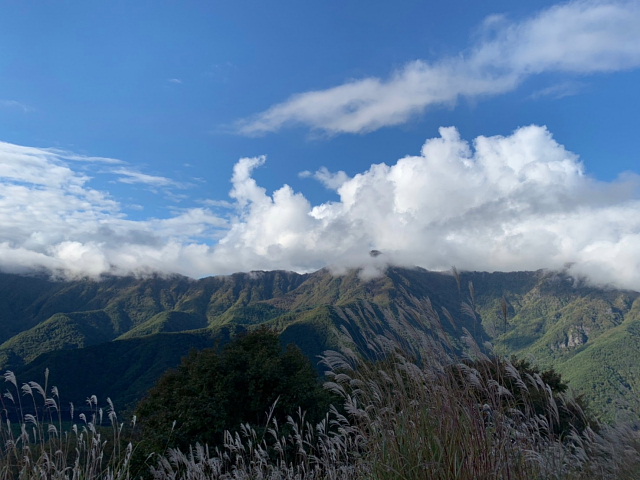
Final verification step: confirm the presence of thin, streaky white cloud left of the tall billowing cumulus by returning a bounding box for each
[0,142,226,276]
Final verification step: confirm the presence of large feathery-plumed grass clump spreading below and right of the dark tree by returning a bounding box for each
[153,316,640,480]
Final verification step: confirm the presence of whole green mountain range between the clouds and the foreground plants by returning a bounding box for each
[0,267,640,419]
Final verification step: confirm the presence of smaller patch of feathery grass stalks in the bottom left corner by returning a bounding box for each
[0,371,133,480]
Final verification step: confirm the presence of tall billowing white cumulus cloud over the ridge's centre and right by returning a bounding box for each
[209,126,640,289]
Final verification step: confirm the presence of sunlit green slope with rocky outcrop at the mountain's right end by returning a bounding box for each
[481,273,640,420]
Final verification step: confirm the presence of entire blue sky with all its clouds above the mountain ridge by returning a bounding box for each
[0,0,640,290]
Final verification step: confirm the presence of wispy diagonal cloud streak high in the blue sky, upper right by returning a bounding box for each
[236,0,640,135]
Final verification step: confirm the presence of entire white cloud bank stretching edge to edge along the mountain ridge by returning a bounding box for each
[0,126,640,290]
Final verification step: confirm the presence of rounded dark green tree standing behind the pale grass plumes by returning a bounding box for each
[136,328,331,452]
